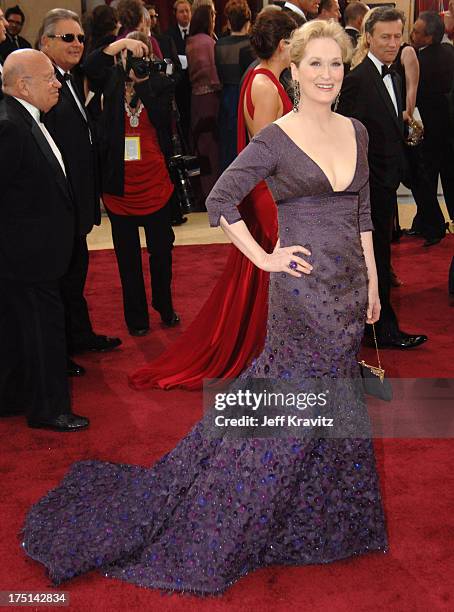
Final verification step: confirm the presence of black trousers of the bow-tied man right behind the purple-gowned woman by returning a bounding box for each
[370,179,399,340]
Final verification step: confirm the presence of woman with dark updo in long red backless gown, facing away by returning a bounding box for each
[130,9,296,390]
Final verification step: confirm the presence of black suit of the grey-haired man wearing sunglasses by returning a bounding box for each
[44,64,101,351]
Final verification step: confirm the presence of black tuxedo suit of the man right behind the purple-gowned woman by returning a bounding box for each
[337,57,404,339]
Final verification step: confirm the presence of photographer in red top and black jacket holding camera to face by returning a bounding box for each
[84,32,180,336]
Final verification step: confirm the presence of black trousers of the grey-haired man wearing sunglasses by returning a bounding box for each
[60,236,94,353]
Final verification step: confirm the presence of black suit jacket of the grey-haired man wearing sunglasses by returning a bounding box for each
[44,69,101,236]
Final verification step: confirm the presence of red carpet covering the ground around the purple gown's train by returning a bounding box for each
[0,237,454,612]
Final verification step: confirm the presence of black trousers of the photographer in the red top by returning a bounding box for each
[108,196,175,329]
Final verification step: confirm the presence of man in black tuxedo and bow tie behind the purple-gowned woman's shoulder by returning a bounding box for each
[337,7,427,349]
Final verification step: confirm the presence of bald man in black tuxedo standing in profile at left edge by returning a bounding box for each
[0,49,89,431]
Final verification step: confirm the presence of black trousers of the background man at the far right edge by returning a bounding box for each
[412,135,454,238]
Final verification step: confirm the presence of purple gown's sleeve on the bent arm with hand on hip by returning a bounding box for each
[206,125,278,227]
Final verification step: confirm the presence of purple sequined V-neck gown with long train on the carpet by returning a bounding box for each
[23,121,387,594]
